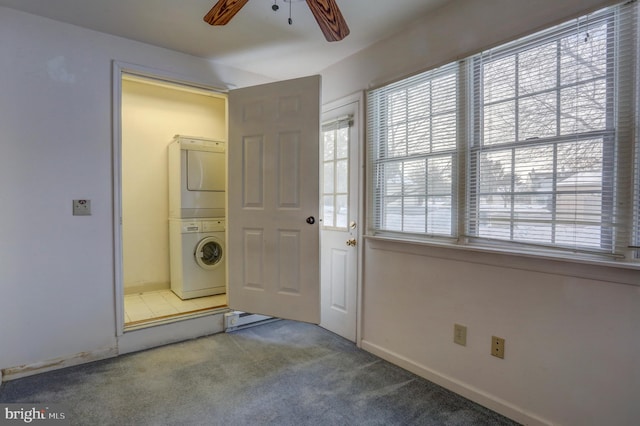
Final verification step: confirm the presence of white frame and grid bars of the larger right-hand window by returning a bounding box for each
[465,9,619,255]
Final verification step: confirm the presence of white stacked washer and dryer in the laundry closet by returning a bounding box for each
[168,135,227,299]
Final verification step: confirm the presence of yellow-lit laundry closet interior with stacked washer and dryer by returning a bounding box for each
[121,75,227,327]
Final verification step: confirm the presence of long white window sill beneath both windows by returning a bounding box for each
[364,235,640,287]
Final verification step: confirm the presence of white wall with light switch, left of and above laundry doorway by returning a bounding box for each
[0,8,268,369]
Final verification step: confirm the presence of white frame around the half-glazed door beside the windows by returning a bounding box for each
[319,91,366,348]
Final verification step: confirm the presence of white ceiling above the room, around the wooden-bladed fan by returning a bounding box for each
[0,0,448,79]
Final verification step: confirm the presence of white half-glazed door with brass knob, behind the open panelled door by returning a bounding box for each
[320,101,359,342]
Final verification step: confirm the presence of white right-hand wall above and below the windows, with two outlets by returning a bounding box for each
[322,0,640,425]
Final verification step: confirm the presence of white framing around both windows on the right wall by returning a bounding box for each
[366,4,640,263]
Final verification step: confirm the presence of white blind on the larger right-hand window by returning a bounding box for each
[466,3,637,255]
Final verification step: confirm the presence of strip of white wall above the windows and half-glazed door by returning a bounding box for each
[322,0,616,102]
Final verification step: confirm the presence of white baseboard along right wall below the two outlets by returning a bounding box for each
[361,339,553,426]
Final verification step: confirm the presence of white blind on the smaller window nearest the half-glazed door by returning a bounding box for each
[367,64,459,236]
